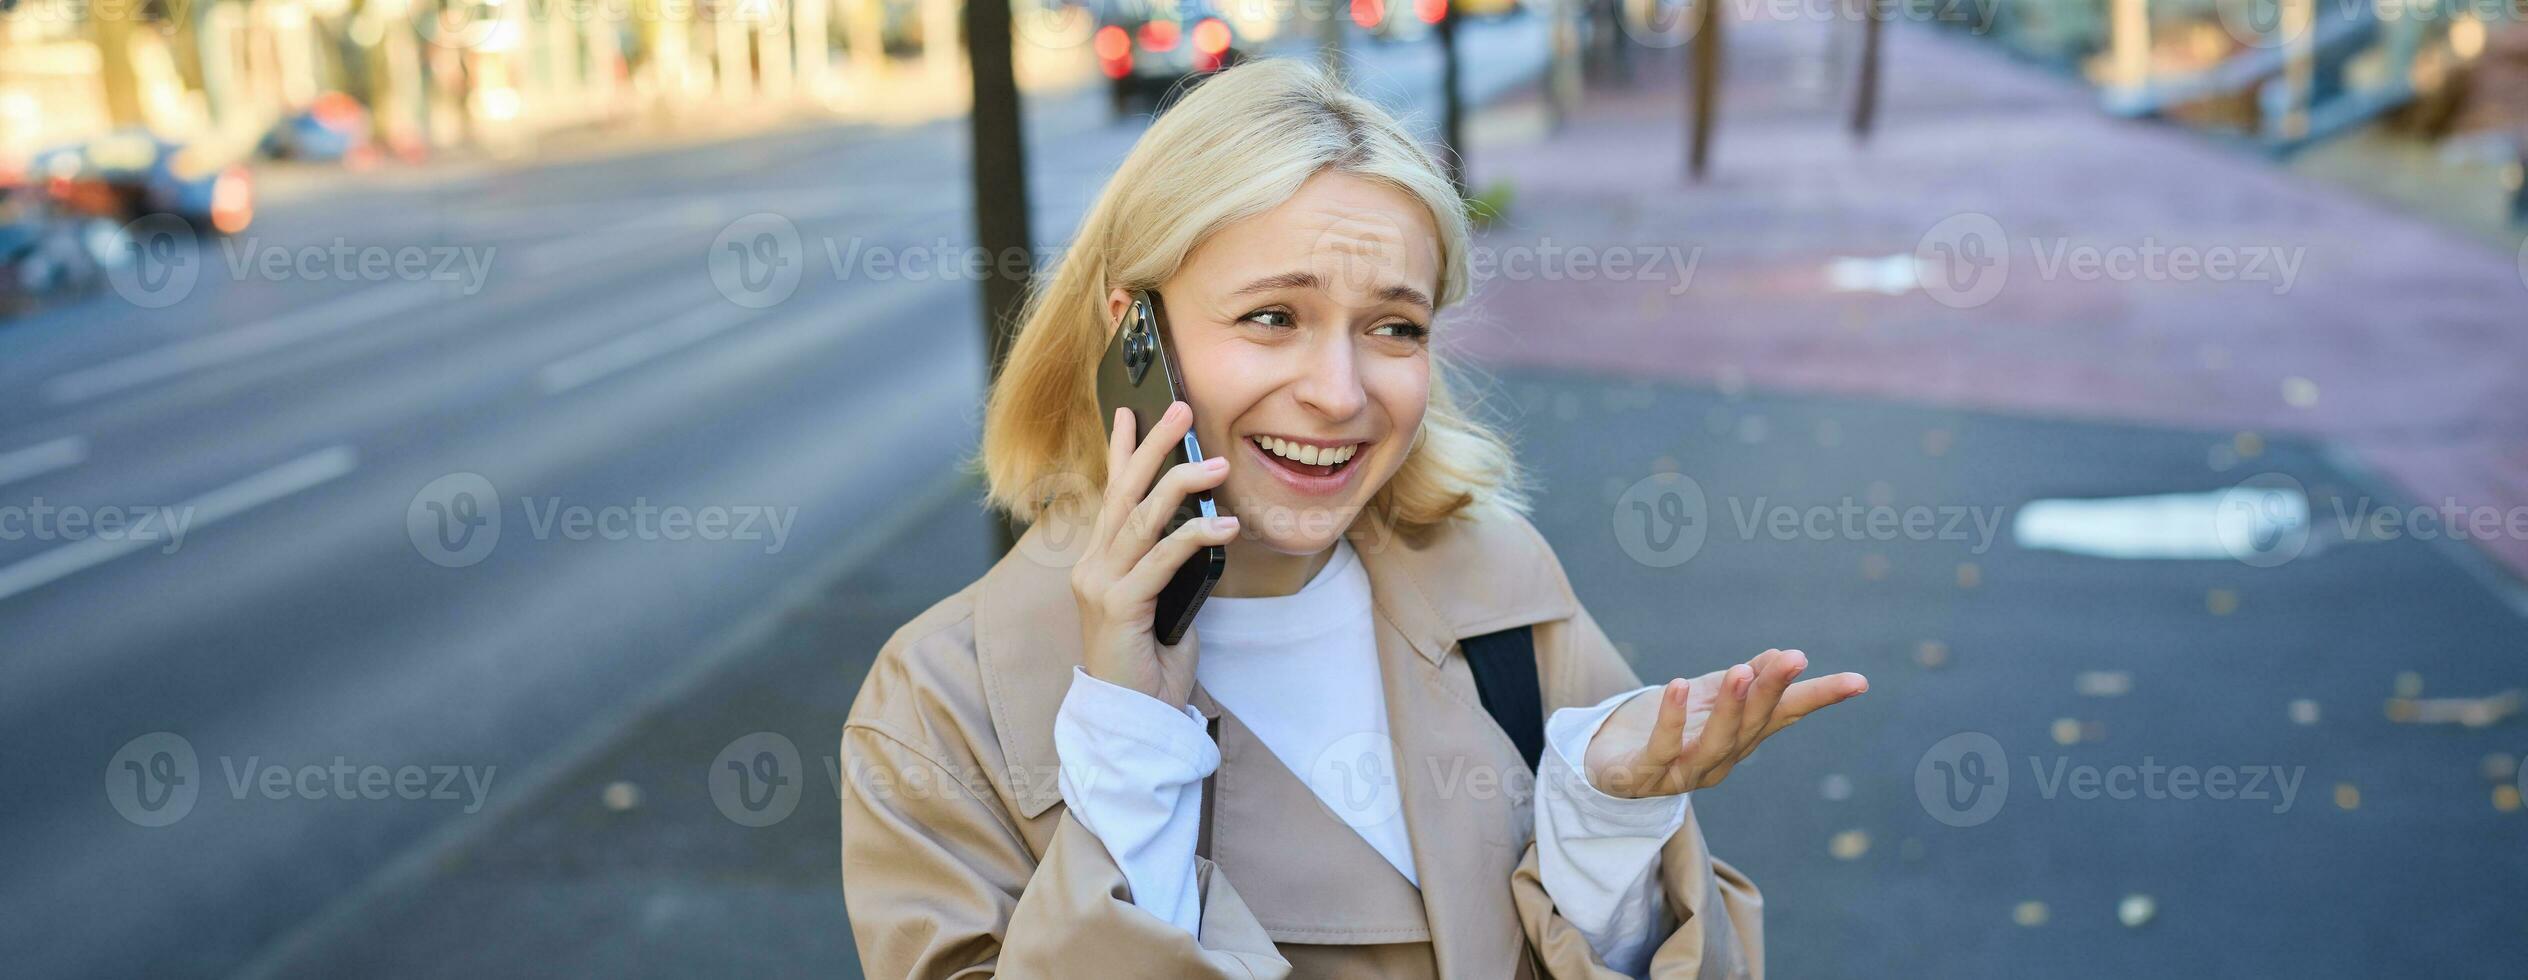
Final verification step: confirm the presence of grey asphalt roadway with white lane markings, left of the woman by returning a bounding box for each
[0,23,1542,975]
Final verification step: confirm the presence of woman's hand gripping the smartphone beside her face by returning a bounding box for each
[1072,402,1239,705]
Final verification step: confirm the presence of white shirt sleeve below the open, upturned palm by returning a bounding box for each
[1537,687,1686,977]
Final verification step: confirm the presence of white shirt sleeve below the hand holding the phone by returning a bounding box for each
[1054,667,1221,935]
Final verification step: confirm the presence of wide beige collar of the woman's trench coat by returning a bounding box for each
[973,505,1577,818]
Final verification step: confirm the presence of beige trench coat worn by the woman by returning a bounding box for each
[842,508,1765,977]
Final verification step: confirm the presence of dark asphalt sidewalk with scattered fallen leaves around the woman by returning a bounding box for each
[232,369,2528,977]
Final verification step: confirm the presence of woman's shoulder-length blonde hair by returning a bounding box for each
[976,58,1527,535]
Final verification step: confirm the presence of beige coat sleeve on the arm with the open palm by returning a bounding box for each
[1509,609,1765,980]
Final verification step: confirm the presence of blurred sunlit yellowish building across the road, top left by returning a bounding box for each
[0,0,1085,164]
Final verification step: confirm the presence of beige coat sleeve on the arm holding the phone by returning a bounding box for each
[842,687,1289,980]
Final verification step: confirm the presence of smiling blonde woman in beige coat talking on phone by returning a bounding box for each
[842,61,1866,977]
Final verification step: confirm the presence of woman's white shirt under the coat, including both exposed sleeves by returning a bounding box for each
[1054,541,1686,977]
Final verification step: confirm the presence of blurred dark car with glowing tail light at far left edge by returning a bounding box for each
[28,129,255,235]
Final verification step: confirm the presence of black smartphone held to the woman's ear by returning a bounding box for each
[1097,290,1229,647]
